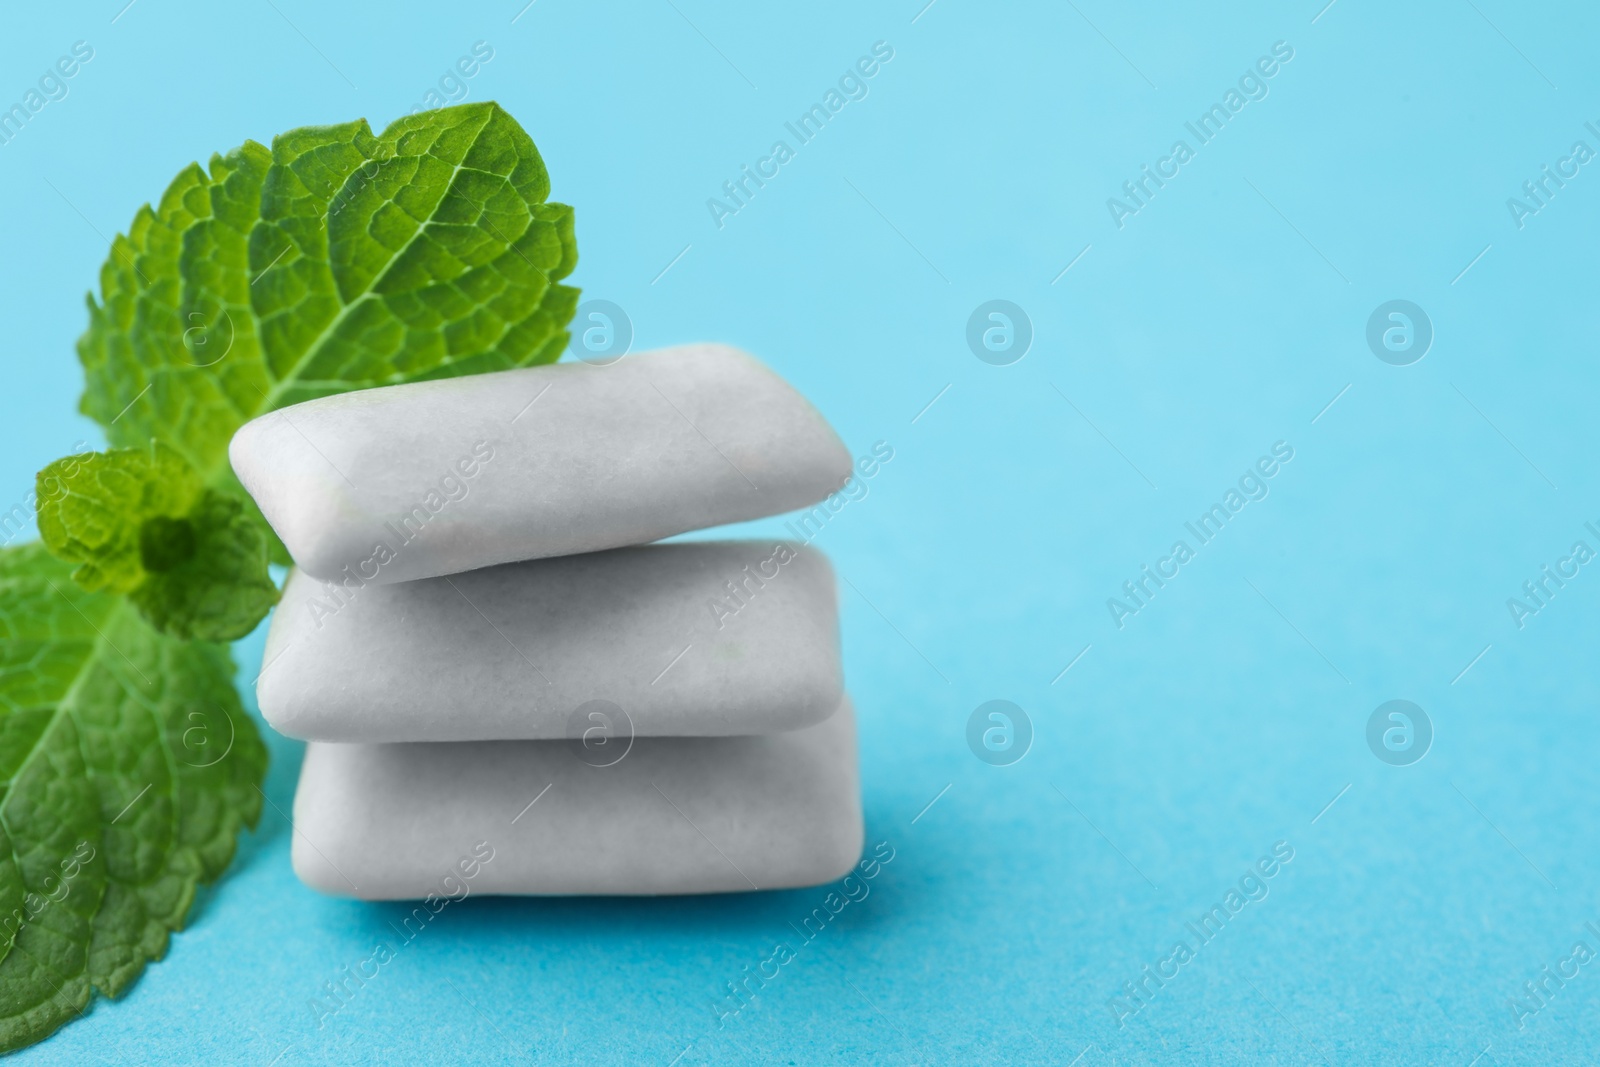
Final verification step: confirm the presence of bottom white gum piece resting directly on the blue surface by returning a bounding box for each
[293,697,862,901]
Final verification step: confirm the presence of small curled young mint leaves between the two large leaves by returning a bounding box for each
[37,442,278,641]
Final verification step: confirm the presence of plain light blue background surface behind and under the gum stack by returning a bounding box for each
[0,0,1600,1067]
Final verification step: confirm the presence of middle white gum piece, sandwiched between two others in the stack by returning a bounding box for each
[256,541,843,742]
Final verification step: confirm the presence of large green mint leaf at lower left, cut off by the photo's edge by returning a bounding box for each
[0,544,266,1051]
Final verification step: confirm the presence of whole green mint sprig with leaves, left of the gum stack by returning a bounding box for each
[0,102,578,1051]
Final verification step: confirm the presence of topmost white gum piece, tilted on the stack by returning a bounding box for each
[229,344,851,584]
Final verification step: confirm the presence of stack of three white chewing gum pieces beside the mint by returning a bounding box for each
[229,344,862,899]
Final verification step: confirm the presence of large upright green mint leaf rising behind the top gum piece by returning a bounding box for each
[78,102,578,492]
